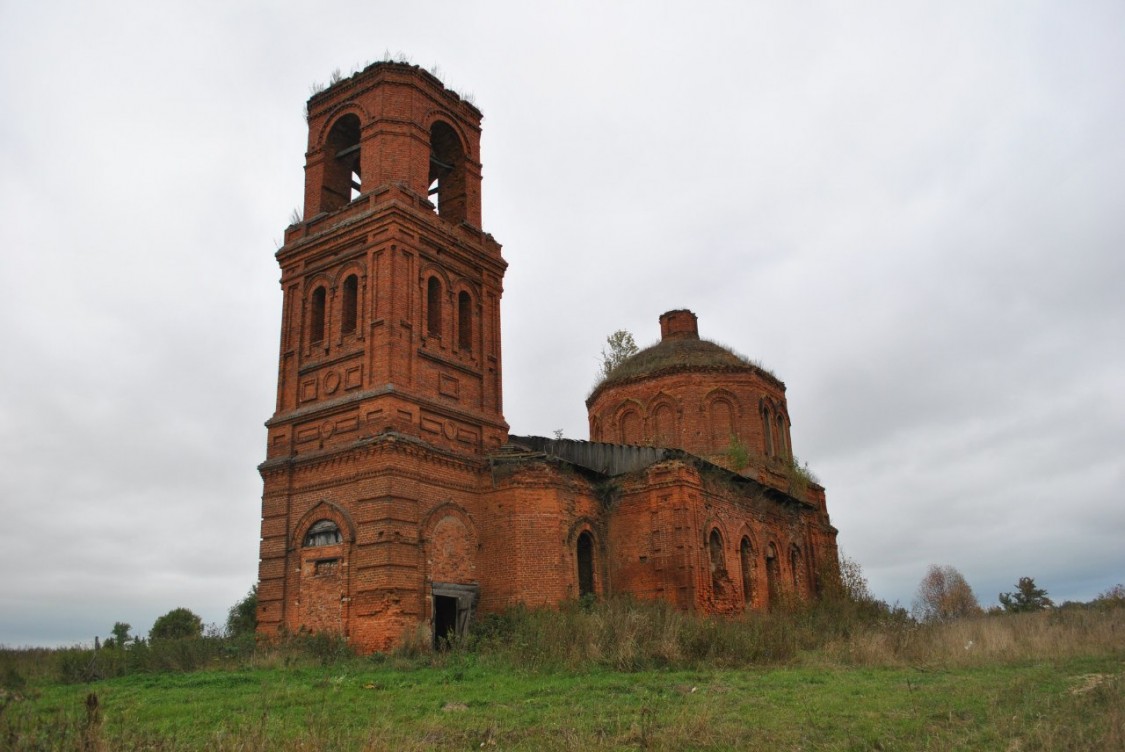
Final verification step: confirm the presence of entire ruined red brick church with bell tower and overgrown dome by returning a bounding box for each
[258,63,838,651]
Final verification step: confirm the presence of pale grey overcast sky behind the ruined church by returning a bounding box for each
[0,0,1125,646]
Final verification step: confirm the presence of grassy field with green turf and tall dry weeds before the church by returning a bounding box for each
[0,599,1125,752]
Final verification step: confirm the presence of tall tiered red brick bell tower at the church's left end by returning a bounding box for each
[259,63,507,646]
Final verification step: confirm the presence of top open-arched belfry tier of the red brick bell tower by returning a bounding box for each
[304,62,482,229]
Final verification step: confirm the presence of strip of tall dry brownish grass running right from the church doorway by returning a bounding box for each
[459,599,1125,671]
